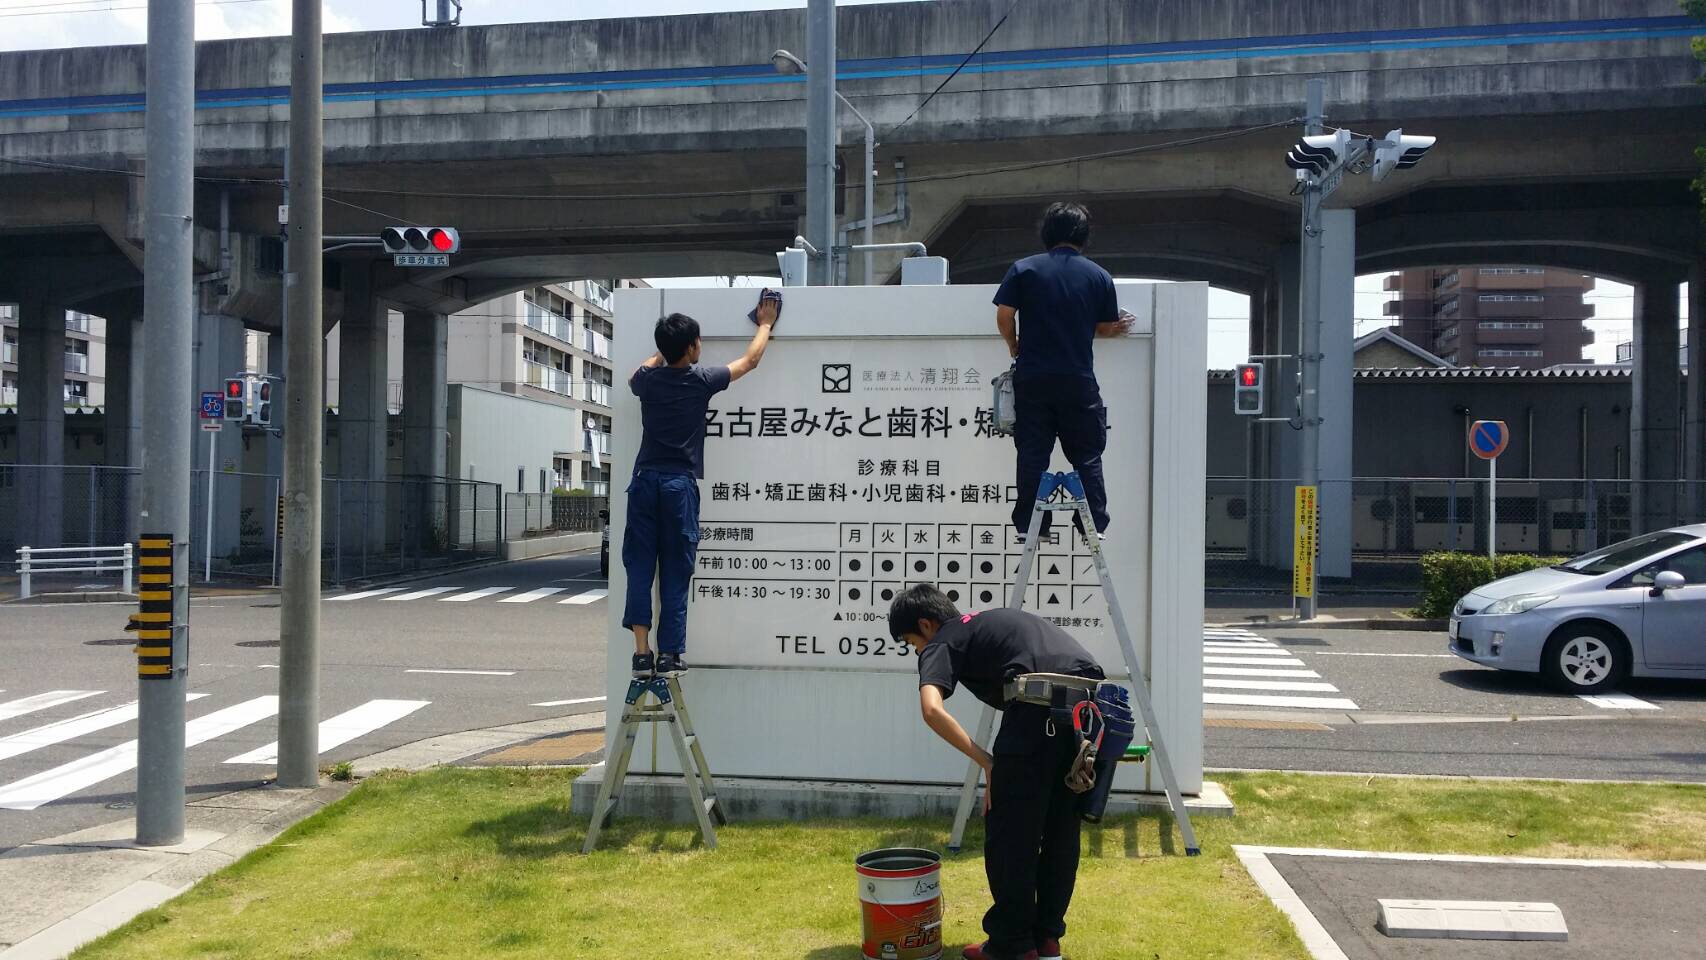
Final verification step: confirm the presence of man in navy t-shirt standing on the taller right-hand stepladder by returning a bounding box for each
[995,203,1131,539]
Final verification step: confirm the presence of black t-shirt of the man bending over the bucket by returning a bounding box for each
[918,607,1105,747]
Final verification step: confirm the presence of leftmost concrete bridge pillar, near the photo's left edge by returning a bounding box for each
[17,298,65,547]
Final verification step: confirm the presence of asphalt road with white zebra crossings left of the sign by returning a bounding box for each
[0,552,607,851]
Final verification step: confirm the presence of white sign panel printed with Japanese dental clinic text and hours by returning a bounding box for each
[688,337,1148,674]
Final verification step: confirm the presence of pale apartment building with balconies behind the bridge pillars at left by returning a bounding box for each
[320,280,647,494]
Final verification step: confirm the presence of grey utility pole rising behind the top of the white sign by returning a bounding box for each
[805,0,836,286]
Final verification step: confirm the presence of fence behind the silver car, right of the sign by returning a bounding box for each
[1204,477,1706,592]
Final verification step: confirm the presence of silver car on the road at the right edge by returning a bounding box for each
[1450,523,1706,694]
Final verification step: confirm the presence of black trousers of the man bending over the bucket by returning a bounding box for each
[983,706,1080,960]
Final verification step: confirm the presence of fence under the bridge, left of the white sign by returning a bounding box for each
[0,466,503,583]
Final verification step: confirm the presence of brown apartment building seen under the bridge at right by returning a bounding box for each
[1385,266,1593,370]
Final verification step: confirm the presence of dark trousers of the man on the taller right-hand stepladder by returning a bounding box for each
[1013,375,1107,535]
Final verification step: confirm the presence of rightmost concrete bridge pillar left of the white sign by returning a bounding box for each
[403,310,450,551]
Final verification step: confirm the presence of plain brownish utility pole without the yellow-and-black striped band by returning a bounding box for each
[278,0,326,788]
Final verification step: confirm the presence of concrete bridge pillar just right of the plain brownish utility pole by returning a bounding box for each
[336,264,391,562]
